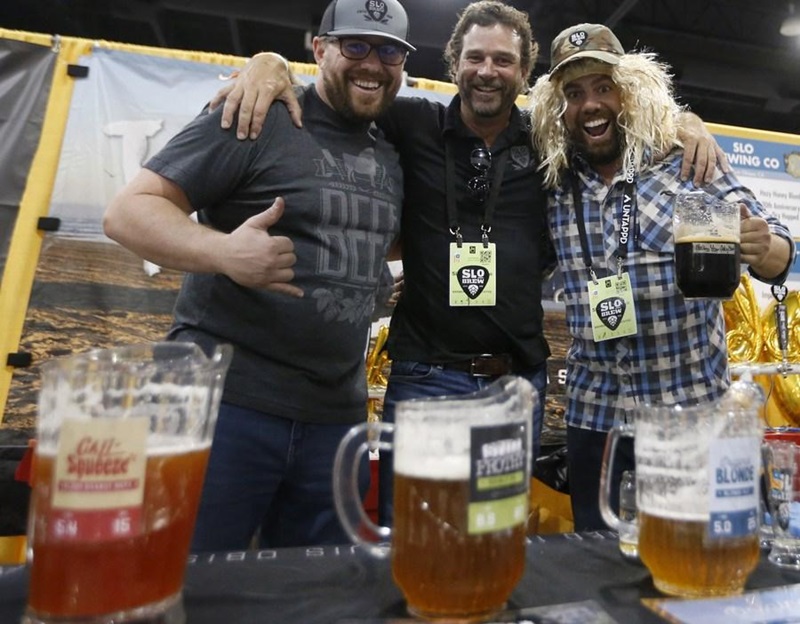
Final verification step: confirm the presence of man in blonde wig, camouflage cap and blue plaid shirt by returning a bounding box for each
[530,24,794,530]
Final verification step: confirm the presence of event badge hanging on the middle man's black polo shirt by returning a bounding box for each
[450,243,497,306]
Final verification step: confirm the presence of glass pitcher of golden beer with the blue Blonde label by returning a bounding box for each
[600,391,763,598]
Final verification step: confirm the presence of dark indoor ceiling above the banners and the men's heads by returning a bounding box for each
[0,0,800,134]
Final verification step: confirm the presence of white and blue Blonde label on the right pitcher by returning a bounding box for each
[708,436,761,538]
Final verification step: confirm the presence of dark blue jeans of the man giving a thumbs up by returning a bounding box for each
[192,403,369,552]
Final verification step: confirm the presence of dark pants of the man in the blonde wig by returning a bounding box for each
[567,427,636,531]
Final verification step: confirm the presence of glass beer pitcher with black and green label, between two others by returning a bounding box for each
[334,376,537,622]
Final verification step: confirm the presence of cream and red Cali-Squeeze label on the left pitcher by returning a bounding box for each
[50,418,149,540]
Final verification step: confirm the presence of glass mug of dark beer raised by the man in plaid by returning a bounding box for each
[672,191,741,299]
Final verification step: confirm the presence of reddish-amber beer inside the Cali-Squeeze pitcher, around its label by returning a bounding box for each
[28,446,210,618]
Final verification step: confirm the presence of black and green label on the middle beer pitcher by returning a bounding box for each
[467,422,530,535]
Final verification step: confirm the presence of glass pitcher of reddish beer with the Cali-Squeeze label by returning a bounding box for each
[22,342,232,624]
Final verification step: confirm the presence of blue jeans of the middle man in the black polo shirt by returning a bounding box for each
[378,361,547,527]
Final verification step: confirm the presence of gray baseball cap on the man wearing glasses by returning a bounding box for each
[319,0,416,52]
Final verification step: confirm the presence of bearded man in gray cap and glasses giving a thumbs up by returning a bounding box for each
[104,0,414,551]
